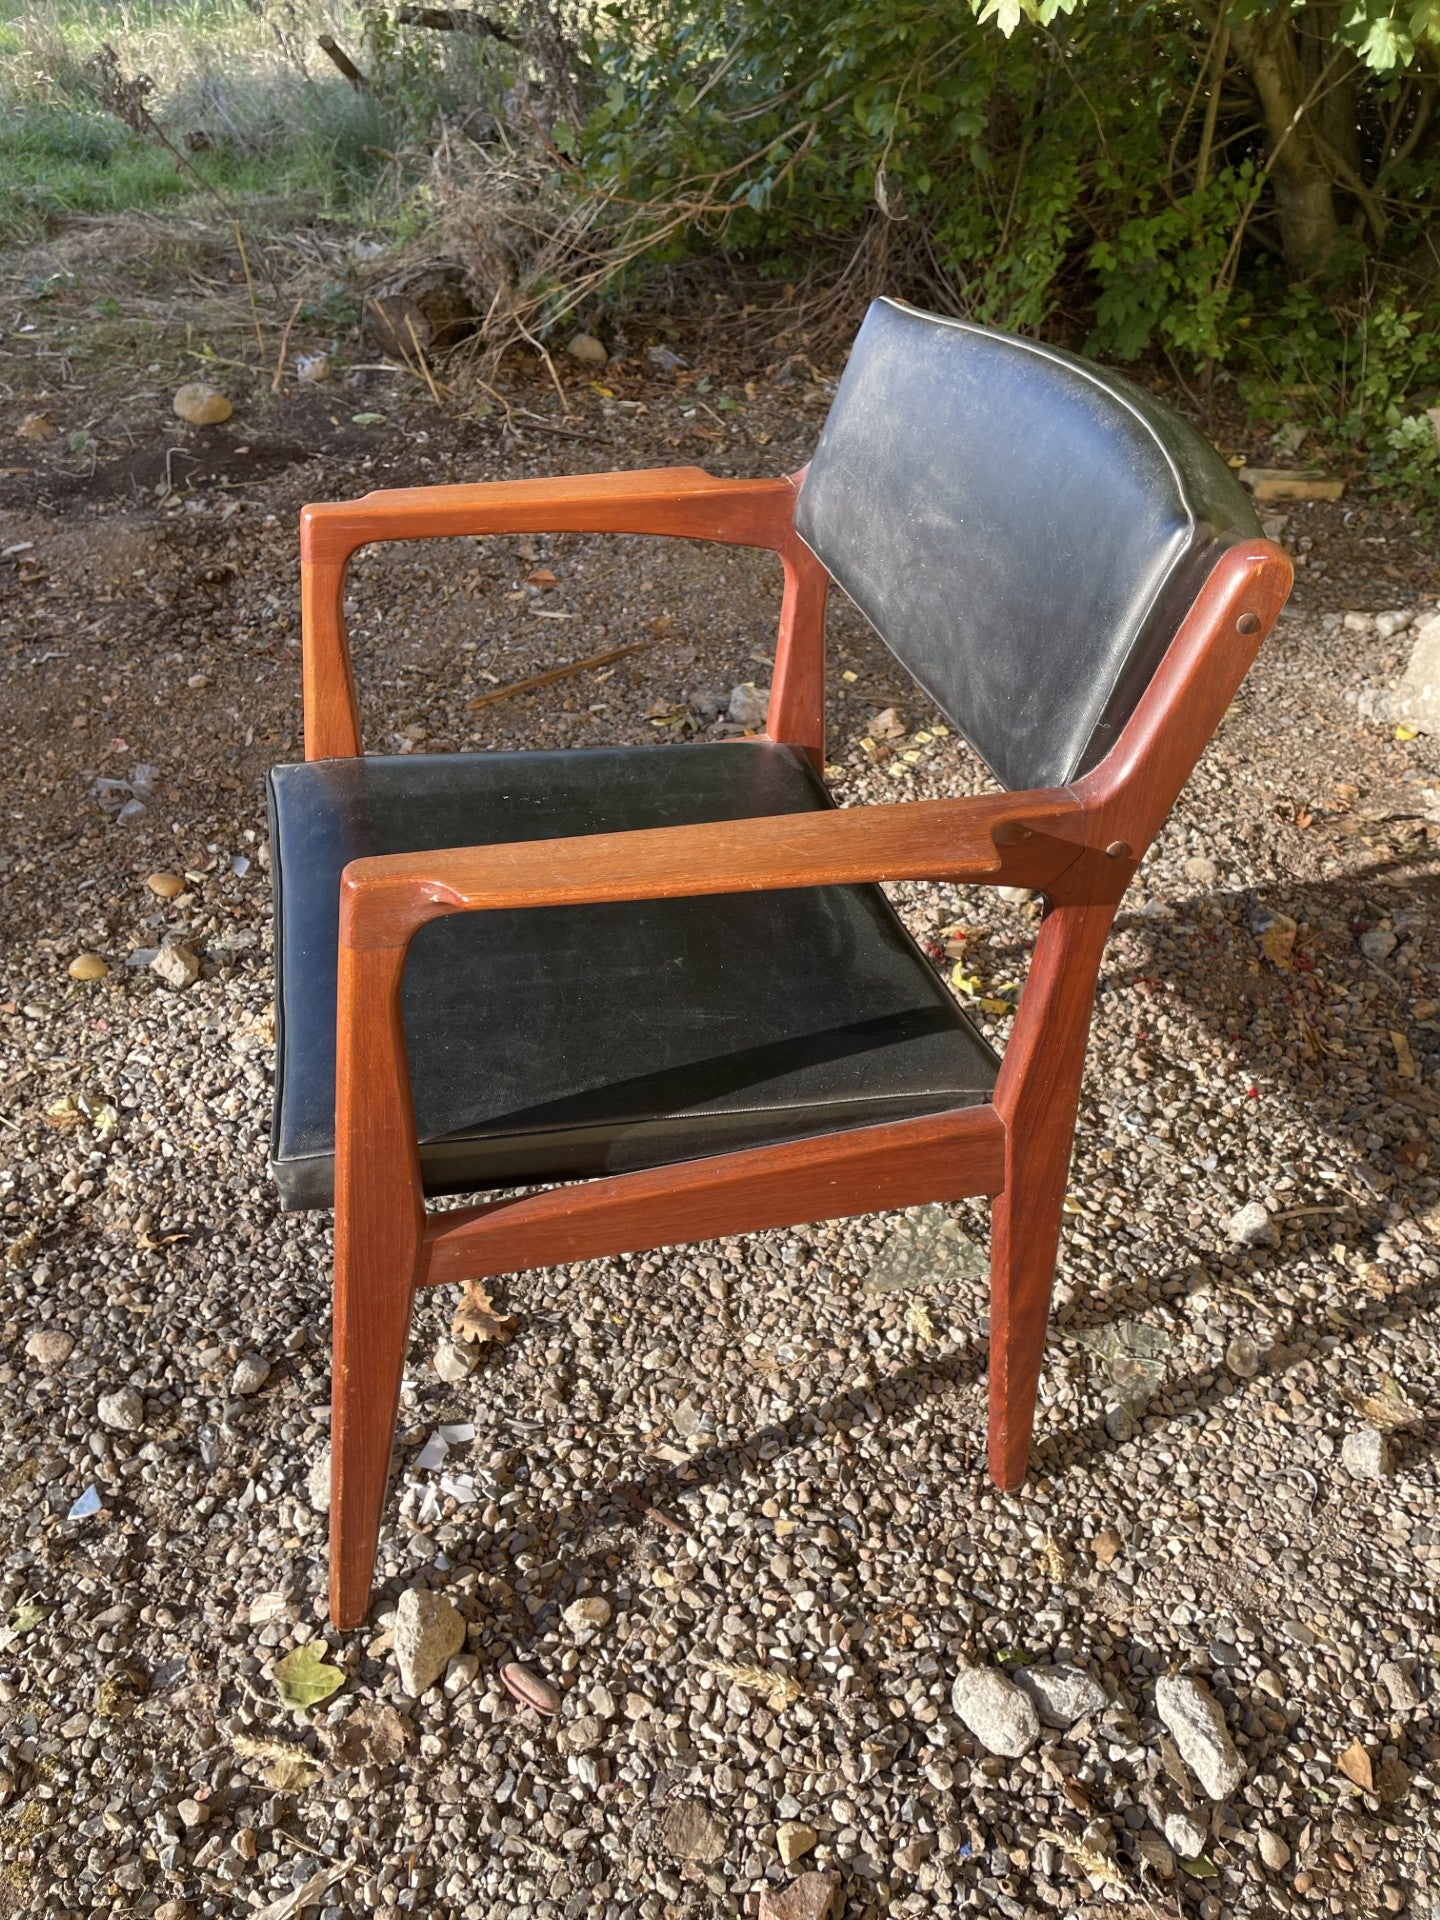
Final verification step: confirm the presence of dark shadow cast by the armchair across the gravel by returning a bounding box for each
[414,856,1440,1638]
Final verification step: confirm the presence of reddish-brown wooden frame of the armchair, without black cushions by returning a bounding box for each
[301,467,1292,1628]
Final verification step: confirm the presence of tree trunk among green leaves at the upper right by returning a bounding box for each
[1231,6,1340,275]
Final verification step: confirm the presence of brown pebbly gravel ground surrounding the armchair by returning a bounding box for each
[0,217,1440,1920]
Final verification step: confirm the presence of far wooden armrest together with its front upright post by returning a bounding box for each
[300,467,810,760]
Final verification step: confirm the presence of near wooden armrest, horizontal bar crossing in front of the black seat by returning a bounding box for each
[340,787,1133,952]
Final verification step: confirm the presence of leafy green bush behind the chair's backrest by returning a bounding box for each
[568,0,1440,493]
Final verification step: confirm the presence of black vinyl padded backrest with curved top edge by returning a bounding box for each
[795,300,1260,789]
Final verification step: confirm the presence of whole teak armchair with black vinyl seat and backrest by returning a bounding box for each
[271,301,1290,1628]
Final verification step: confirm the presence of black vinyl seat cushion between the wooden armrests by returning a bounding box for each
[269,741,998,1210]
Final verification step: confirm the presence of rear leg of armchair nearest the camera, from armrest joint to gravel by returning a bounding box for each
[989,904,1116,1492]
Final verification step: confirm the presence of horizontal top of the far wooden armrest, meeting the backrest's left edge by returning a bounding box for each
[300,467,799,566]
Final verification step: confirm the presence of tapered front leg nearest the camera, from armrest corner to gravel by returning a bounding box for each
[330,939,424,1630]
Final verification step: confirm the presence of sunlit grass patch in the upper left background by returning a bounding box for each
[0,0,503,246]
